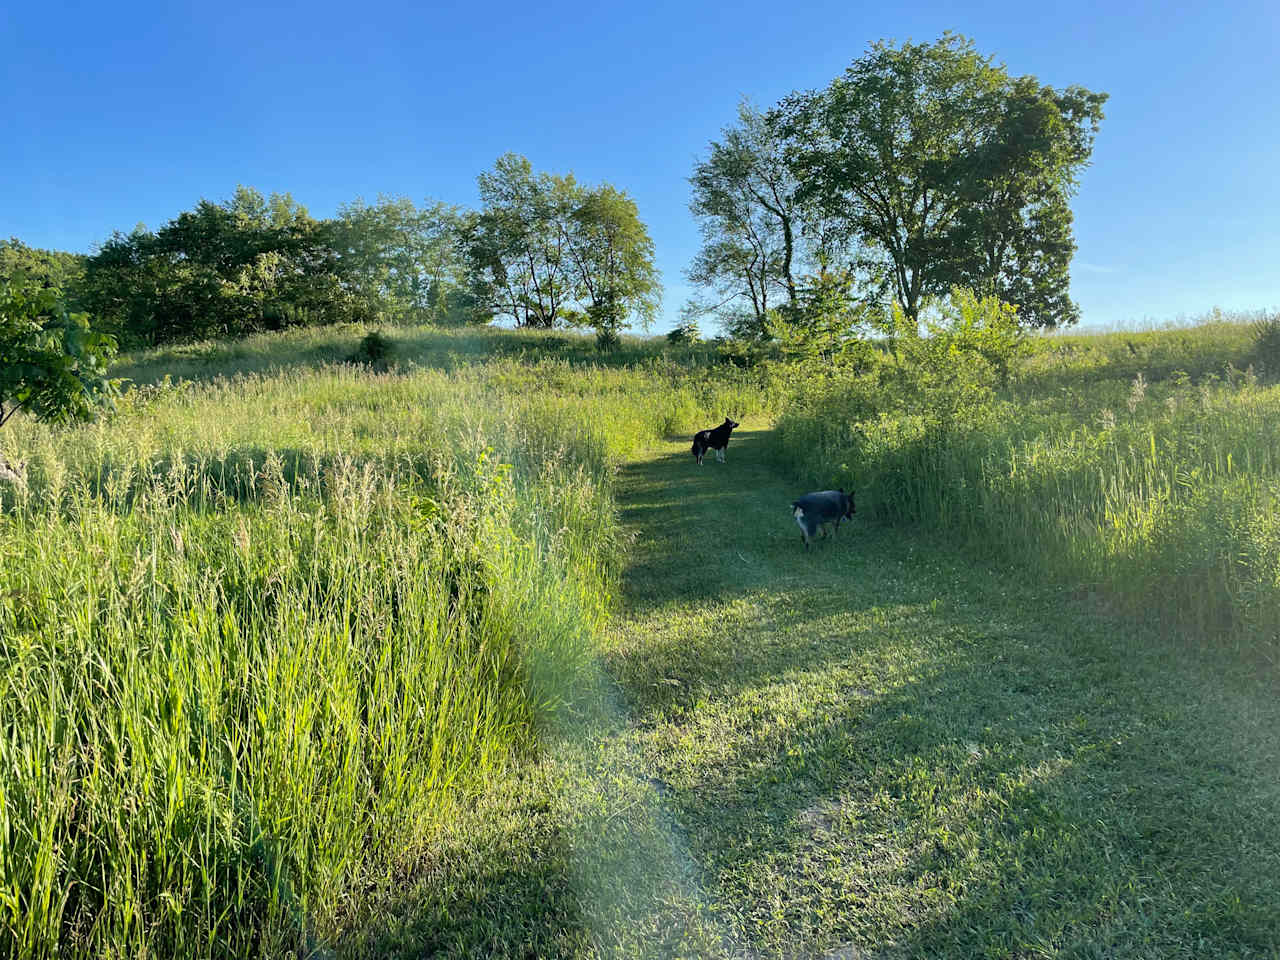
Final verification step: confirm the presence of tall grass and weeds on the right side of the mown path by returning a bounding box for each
[778,320,1280,658]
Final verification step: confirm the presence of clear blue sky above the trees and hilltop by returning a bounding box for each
[0,0,1280,330]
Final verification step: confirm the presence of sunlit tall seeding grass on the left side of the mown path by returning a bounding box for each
[0,343,762,957]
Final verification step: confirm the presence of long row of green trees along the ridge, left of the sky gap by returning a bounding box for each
[0,154,660,346]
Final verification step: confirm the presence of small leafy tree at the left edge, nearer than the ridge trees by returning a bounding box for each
[0,271,118,479]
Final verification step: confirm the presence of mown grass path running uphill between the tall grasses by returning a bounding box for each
[351,430,1280,959]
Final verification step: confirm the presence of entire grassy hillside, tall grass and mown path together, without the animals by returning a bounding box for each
[0,320,1280,957]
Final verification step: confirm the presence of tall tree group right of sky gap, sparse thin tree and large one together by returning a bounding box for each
[690,33,1106,335]
